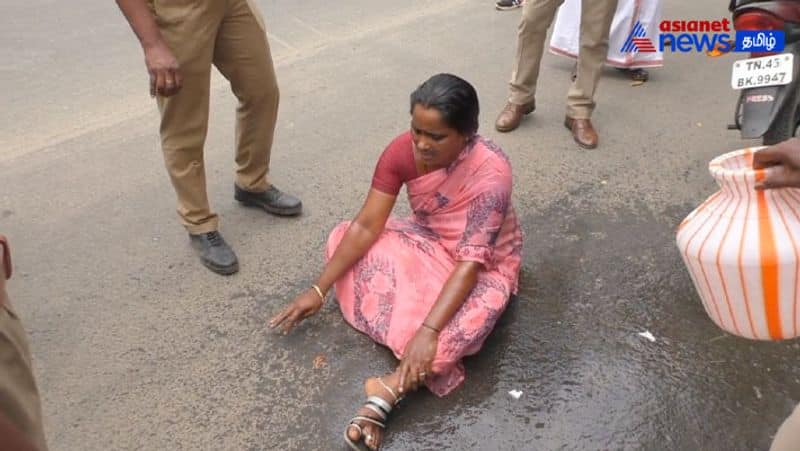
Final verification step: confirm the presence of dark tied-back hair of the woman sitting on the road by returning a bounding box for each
[411,74,480,135]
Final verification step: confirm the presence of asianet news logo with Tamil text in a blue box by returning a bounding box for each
[620,19,785,56]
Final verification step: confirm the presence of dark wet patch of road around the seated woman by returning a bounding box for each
[265,189,800,450]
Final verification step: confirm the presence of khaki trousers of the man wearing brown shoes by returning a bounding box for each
[509,0,618,119]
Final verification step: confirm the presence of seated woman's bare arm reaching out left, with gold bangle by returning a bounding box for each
[269,188,397,333]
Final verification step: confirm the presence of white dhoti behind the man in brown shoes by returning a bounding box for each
[550,0,664,69]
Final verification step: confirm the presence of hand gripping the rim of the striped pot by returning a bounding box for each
[753,138,800,189]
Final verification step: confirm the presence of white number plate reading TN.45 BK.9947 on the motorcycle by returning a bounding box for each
[731,53,794,90]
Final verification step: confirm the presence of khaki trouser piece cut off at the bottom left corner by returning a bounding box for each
[0,304,47,451]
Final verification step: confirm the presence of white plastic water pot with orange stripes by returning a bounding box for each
[677,148,800,340]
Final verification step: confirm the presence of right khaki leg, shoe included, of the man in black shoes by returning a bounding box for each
[214,0,302,216]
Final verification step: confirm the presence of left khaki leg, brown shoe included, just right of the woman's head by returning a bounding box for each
[495,0,564,132]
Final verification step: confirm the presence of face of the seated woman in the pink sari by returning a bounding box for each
[411,104,469,170]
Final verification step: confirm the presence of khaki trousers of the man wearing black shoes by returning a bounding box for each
[149,0,279,234]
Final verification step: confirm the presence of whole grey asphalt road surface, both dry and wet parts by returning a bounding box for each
[0,0,800,451]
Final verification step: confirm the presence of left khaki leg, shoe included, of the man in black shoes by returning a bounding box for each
[156,0,239,274]
